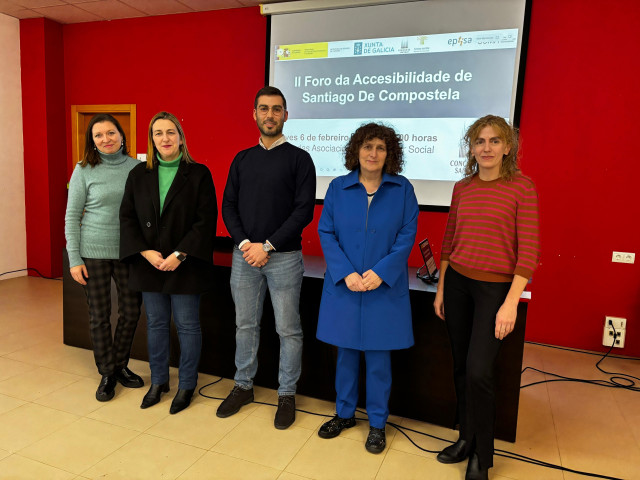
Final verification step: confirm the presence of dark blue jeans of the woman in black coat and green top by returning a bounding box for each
[142,292,202,390]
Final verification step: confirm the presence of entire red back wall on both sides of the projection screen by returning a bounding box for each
[18,0,640,356]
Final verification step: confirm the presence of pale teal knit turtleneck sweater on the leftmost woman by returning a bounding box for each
[64,149,140,267]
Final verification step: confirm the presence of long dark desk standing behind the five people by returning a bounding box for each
[63,252,527,442]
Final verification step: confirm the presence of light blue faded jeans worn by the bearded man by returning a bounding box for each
[231,248,304,395]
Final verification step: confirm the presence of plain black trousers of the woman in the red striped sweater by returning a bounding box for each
[444,266,511,468]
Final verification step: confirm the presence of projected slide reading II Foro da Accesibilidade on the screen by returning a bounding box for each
[273,29,518,181]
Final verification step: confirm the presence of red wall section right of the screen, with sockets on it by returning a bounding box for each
[521,0,640,356]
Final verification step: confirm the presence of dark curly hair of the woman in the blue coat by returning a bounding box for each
[344,123,404,175]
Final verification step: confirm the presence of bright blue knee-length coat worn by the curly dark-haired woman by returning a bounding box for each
[317,170,418,350]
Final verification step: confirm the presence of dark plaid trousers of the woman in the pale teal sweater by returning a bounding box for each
[83,258,142,375]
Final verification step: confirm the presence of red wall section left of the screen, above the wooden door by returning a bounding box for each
[64,8,266,240]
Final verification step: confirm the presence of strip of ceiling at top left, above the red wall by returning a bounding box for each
[0,0,292,23]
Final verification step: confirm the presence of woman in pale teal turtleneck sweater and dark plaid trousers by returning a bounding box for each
[65,114,144,402]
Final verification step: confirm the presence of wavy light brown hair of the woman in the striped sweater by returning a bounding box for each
[462,115,520,181]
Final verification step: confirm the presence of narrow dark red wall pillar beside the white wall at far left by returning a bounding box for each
[20,18,67,276]
